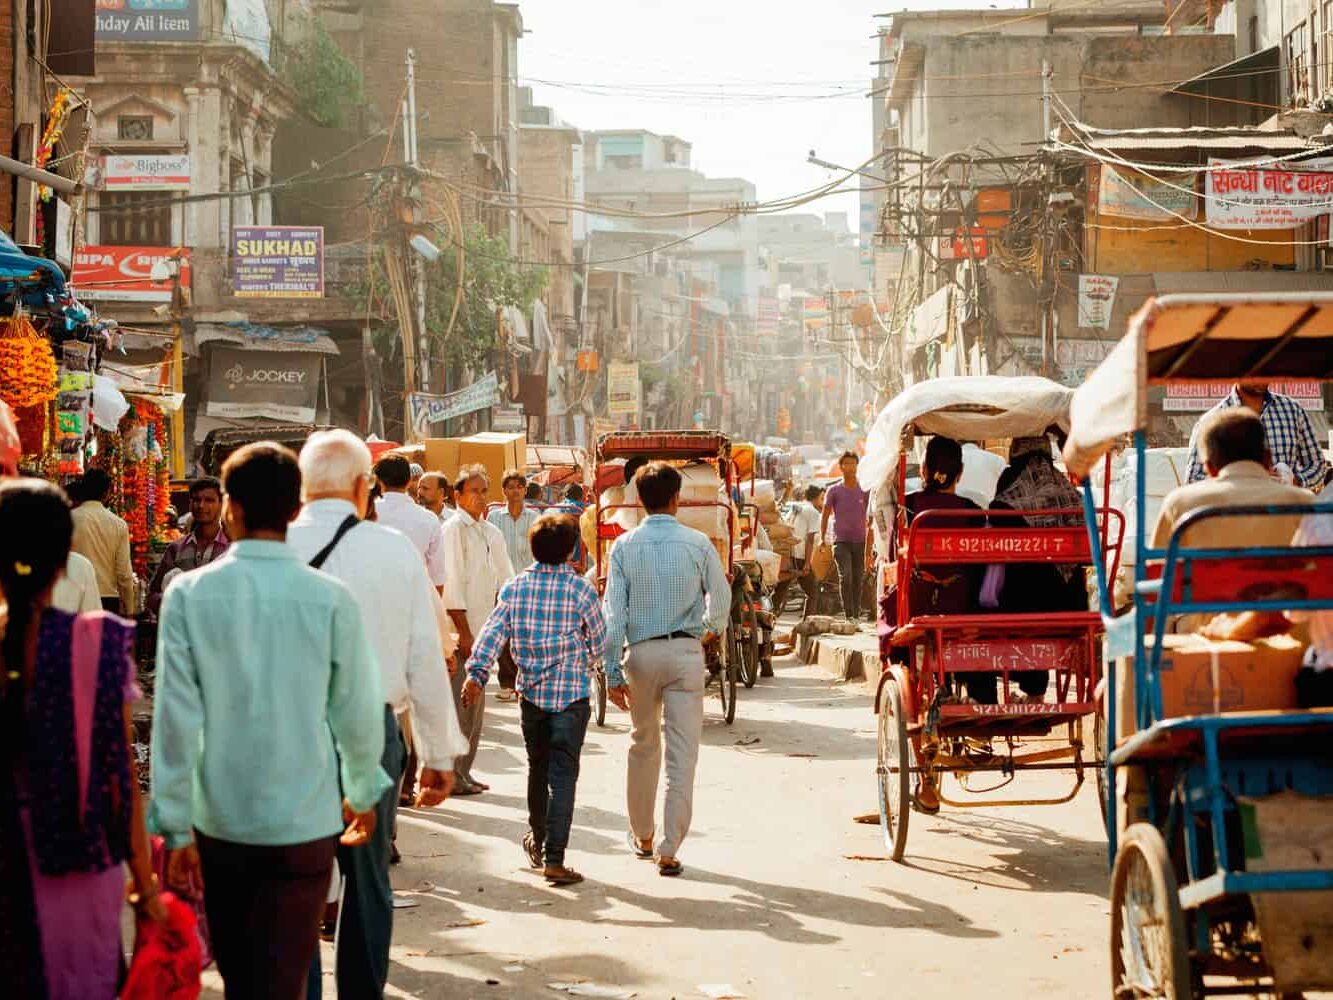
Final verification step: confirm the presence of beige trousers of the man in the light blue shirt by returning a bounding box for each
[625,639,704,857]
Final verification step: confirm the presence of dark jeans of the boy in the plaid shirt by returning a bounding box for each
[523,699,591,865]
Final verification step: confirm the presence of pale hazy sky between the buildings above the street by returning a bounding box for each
[519,0,1026,225]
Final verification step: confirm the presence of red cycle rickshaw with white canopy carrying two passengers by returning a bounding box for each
[861,376,1124,861]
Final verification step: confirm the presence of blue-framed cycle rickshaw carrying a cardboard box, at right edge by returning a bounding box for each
[1065,293,1333,1000]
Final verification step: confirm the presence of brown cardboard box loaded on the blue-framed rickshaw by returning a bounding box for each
[1116,635,1305,741]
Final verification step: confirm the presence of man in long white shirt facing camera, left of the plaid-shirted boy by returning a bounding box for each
[441,465,513,795]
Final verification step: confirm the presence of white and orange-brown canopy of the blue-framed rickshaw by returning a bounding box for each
[1065,292,1333,476]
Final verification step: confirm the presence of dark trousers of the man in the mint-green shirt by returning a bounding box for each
[195,831,337,1000]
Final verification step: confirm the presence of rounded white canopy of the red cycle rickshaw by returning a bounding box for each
[860,375,1073,496]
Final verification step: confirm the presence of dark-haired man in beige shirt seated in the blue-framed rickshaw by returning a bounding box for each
[1153,407,1314,548]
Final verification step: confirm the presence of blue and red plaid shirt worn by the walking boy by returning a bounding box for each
[468,563,607,712]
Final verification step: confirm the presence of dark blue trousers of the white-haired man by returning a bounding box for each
[311,708,407,1000]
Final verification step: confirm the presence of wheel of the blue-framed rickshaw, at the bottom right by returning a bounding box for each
[1110,823,1196,1000]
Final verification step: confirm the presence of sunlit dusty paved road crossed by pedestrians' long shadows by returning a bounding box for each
[286,661,1108,1000]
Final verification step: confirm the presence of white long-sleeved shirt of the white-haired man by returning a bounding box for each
[287,500,468,771]
